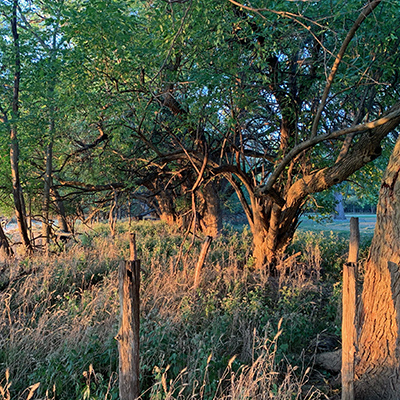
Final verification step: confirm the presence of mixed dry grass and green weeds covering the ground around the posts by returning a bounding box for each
[0,221,374,400]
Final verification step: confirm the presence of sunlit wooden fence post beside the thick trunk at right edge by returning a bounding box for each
[342,218,360,400]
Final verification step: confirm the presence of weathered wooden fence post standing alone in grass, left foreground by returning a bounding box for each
[117,233,140,400]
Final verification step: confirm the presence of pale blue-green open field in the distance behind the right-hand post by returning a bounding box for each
[299,214,376,235]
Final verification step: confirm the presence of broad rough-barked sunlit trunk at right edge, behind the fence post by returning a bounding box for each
[355,134,400,400]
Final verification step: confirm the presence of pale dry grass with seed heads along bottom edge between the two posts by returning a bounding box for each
[146,321,328,400]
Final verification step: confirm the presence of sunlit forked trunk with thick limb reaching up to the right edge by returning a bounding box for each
[250,103,400,266]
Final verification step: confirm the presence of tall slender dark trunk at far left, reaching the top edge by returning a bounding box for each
[10,0,33,252]
